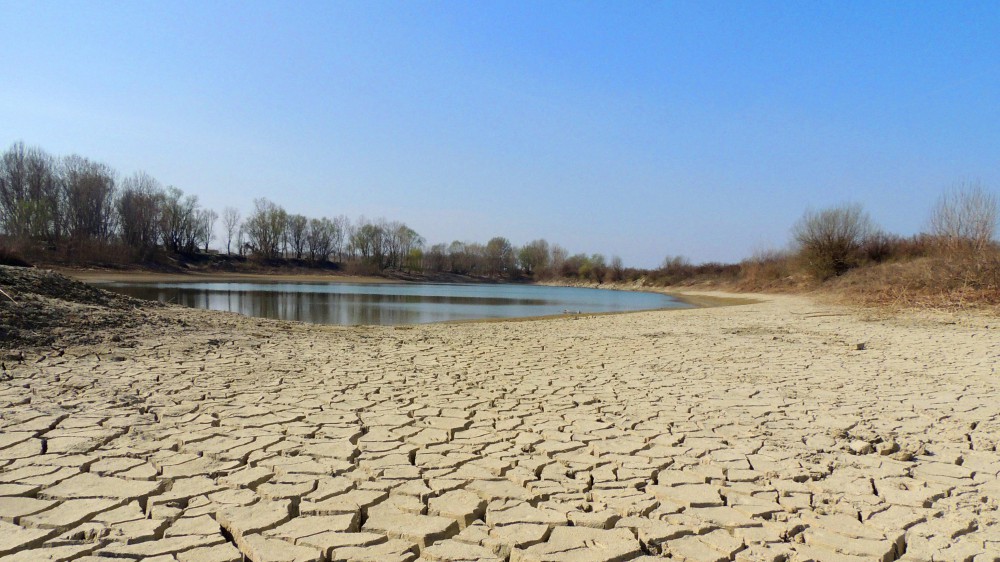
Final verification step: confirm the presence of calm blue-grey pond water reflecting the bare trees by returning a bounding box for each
[103,283,688,325]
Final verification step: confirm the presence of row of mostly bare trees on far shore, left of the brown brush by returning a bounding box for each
[0,142,638,282]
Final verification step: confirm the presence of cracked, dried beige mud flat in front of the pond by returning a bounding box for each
[0,288,1000,562]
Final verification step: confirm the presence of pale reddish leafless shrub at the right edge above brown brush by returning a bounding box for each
[930,182,1000,254]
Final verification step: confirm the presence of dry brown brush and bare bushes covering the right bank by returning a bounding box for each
[650,190,1000,308]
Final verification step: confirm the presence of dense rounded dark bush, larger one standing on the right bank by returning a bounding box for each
[792,204,878,279]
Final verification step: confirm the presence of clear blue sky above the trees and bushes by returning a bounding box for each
[0,0,1000,266]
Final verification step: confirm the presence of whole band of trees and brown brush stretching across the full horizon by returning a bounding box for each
[0,142,1000,304]
